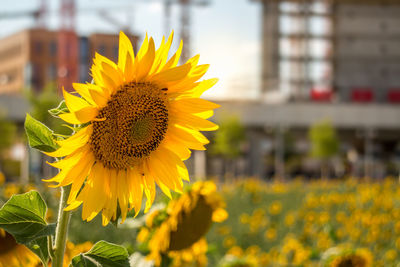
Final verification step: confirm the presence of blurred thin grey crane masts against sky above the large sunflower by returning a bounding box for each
[164,0,210,62]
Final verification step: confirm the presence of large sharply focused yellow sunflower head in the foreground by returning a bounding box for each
[46,32,219,225]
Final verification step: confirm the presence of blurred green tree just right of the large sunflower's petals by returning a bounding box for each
[210,116,246,159]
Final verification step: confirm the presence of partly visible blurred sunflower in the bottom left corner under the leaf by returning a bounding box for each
[0,229,40,267]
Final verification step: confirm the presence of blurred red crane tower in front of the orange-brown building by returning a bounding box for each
[57,0,79,91]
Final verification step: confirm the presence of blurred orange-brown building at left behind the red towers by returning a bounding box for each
[0,29,138,94]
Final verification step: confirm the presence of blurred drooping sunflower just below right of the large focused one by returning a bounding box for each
[139,182,228,266]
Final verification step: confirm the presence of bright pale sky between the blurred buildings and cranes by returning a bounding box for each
[0,0,261,99]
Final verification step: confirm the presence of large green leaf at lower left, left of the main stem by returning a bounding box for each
[0,191,56,262]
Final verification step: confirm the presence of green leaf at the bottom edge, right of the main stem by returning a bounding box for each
[70,241,129,267]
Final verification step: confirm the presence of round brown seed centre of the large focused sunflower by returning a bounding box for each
[90,82,168,169]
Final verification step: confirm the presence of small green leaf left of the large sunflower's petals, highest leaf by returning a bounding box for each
[25,114,58,152]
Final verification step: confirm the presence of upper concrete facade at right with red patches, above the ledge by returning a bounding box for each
[254,0,400,104]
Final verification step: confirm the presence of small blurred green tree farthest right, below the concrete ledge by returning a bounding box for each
[309,120,339,159]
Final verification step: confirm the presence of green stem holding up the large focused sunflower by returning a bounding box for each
[51,186,71,267]
